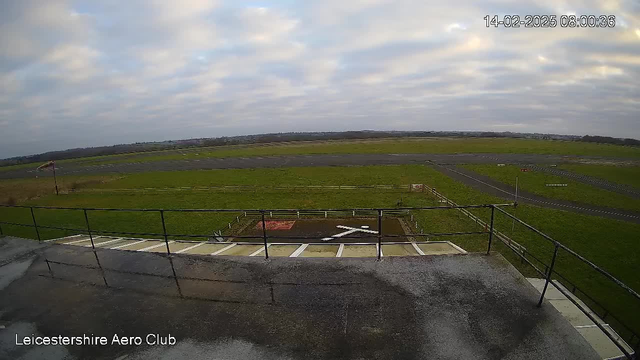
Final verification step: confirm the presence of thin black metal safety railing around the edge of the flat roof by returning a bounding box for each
[0,202,640,359]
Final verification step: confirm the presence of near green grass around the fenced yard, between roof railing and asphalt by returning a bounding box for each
[0,165,640,338]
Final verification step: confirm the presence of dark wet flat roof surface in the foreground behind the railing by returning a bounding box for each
[0,238,598,360]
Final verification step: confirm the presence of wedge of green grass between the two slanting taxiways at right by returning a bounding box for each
[463,165,640,211]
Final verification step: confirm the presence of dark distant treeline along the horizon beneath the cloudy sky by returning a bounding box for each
[0,130,640,166]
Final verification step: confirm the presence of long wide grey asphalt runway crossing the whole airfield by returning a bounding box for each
[0,154,633,179]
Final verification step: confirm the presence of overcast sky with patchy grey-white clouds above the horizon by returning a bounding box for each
[0,0,640,158]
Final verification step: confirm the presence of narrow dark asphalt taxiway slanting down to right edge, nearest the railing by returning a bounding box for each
[433,165,640,224]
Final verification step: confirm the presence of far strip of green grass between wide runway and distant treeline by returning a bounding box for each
[5,138,640,171]
